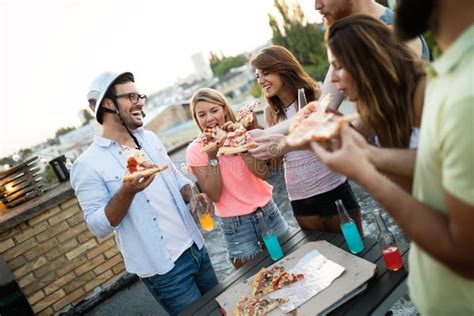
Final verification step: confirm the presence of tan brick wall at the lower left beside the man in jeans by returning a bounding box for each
[0,194,125,315]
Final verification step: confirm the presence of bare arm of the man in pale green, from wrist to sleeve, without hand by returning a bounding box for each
[362,169,474,280]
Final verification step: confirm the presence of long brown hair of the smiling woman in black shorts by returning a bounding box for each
[250,45,321,125]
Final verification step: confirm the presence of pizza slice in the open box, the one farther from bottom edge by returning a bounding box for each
[251,266,304,297]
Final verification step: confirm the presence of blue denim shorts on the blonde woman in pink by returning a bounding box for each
[220,200,288,260]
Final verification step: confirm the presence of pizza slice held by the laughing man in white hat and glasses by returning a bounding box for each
[122,146,168,181]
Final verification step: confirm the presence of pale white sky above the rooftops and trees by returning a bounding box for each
[0,0,320,157]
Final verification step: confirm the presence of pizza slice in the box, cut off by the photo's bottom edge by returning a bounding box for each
[232,297,287,316]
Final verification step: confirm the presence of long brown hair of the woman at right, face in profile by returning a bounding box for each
[327,15,424,148]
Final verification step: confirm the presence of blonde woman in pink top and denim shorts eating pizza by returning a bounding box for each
[186,88,288,268]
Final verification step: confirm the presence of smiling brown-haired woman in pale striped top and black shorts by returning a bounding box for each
[250,46,362,233]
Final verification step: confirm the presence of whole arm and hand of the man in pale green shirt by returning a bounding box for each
[312,126,474,279]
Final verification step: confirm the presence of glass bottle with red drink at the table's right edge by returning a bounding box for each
[374,209,403,271]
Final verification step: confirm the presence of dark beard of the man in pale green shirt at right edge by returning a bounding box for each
[394,0,438,41]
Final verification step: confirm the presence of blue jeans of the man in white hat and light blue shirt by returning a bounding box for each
[141,244,217,315]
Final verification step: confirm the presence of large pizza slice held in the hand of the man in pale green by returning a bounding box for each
[286,112,359,147]
